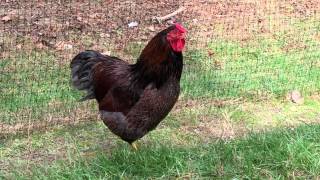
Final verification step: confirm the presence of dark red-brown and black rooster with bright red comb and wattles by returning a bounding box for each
[70,23,186,149]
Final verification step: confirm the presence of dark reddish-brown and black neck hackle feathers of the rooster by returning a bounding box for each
[132,27,182,87]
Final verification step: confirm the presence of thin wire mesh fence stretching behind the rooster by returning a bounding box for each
[0,0,320,137]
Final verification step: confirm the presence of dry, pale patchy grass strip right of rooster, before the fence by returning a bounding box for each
[172,95,320,141]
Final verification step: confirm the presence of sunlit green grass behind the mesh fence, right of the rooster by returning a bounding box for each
[182,21,320,98]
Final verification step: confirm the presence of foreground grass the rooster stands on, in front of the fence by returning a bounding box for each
[0,95,320,179]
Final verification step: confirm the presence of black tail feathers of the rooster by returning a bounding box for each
[70,51,103,101]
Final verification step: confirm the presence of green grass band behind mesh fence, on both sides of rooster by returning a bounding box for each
[0,20,320,124]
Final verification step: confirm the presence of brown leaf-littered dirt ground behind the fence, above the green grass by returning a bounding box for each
[0,0,320,55]
